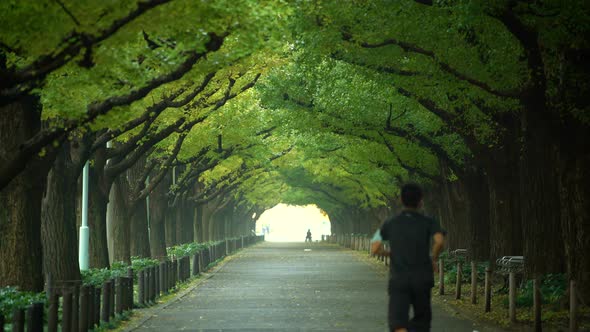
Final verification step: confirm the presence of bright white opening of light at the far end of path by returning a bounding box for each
[256,204,331,242]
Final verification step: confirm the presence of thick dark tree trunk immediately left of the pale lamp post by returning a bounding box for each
[41,143,80,280]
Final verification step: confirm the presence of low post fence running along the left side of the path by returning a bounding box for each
[0,236,264,332]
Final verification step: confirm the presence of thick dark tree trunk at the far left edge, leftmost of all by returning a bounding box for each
[0,97,45,291]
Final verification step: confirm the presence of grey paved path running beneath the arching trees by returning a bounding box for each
[130,242,504,332]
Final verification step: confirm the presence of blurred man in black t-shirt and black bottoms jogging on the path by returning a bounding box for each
[371,184,444,332]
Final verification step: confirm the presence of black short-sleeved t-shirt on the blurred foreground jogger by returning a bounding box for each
[381,210,444,280]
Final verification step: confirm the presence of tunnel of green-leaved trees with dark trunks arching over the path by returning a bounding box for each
[0,0,590,296]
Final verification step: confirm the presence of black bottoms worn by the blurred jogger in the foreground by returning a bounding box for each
[388,278,432,332]
